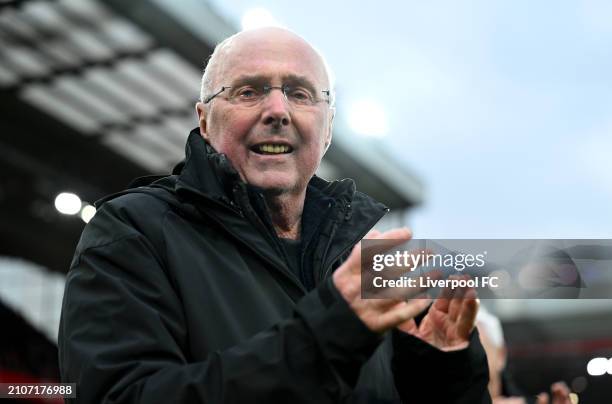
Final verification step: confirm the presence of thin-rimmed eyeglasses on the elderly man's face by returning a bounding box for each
[204,84,331,108]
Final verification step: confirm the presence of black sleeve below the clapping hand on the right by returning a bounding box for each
[391,329,491,404]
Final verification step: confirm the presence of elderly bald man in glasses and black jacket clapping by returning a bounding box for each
[59,28,490,403]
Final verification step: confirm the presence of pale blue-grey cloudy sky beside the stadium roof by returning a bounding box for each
[207,0,612,238]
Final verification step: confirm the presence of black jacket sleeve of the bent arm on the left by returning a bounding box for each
[58,219,380,404]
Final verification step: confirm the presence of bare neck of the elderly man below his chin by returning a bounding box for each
[265,190,306,240]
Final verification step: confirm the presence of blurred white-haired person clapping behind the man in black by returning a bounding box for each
[476,307,572,404]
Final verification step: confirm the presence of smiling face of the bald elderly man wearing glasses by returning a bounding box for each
[197,30,332,194]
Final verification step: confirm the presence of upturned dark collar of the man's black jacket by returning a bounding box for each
[173,128,389,288]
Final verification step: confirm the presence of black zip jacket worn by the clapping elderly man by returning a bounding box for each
[59,130,488,404]
